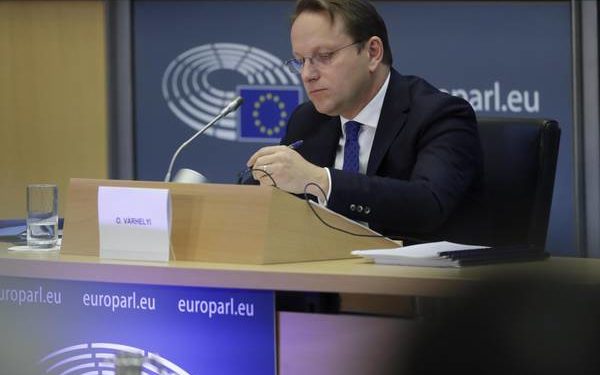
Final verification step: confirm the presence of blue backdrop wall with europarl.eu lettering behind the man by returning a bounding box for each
[134,1,576,255]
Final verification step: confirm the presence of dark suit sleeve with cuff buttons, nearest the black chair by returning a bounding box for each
[328,95,482,235]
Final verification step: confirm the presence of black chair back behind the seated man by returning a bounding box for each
[478,118,560,249]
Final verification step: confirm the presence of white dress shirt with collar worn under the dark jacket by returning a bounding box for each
[325,73,390,199]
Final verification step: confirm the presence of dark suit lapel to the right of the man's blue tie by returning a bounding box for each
[367,69,409,176]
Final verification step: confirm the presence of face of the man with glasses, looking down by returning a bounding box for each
[291,12,372,118]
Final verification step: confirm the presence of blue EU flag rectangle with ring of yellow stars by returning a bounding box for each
[237,85,302,142]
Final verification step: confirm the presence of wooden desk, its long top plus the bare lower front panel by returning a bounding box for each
[0,243,600,375]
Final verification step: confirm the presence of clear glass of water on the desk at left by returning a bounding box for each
[27,184,58,249]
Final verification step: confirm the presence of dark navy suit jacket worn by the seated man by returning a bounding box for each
[282,69,483,243]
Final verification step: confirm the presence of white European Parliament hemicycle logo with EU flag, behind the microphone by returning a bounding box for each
[161,43,301,142]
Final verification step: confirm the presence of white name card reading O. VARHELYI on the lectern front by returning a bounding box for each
[98,186,171,262]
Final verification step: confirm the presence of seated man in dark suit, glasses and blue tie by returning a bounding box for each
[247,0,483,242]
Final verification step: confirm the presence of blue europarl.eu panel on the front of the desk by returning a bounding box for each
[0,277,277,375]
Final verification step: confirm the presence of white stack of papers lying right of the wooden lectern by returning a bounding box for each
[352,241,489,267]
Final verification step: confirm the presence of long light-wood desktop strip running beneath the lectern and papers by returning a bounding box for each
[0,243,600,297]
